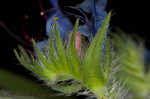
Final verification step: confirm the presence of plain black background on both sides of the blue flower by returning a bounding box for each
[0,0,150,97]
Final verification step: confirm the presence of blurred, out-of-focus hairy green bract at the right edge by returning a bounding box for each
[113,33,150,99]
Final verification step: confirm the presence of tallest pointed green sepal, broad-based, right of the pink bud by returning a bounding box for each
[82,13,111,90]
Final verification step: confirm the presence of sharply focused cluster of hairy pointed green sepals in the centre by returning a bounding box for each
[15,13,115,99]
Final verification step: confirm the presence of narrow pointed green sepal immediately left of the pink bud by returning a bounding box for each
[67,20,81,79]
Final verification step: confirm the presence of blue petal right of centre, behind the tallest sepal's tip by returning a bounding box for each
[78,0,107,39]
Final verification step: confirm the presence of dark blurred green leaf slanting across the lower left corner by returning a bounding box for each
[0,70,50,96]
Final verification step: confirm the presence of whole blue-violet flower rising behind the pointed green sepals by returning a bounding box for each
[38,0,107,48]
